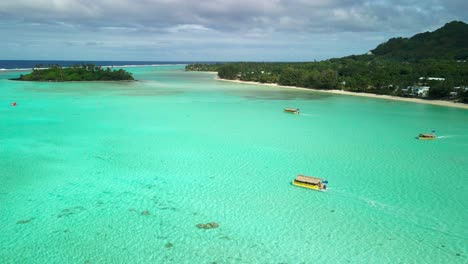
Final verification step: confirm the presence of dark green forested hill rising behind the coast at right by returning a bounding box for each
[372,21,468,61]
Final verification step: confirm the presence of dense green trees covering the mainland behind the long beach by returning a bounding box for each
[186,22,468,102]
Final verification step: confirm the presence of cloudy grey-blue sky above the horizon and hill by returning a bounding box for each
[0,0,468,61]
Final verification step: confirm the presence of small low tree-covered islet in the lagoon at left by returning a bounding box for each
[12,64,134,82]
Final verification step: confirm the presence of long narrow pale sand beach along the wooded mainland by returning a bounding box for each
[215,77,468,110]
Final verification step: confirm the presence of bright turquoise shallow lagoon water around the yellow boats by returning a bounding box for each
[0,66,468,263]
